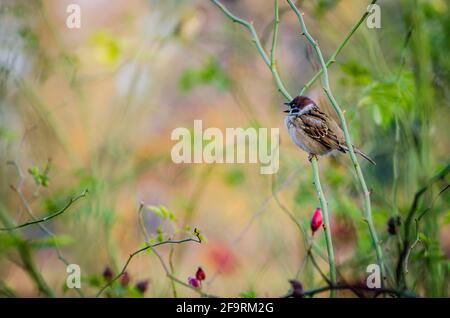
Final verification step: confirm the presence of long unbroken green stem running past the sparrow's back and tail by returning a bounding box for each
[287,0,386,286]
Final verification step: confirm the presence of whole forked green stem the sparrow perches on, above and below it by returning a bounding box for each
[211,0,336,296]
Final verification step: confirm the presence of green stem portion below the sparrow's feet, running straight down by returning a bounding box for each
[311,156,336,297]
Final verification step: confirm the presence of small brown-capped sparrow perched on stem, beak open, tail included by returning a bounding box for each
[284,96,375,164]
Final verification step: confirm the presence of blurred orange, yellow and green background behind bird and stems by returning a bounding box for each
[0,0,450,297]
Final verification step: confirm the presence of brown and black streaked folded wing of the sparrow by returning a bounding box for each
[300,108,345,152]
